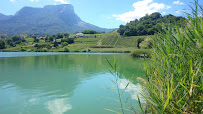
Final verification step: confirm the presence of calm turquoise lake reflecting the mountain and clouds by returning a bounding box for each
[0,52,144,114]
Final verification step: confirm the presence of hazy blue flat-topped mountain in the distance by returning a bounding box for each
[0,4,110,34]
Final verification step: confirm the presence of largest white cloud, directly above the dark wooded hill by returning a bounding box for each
[112,0,171,22]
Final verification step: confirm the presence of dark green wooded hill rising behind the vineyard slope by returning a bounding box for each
[118,12,185,36]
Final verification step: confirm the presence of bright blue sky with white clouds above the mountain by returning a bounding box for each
[0,0,203,28]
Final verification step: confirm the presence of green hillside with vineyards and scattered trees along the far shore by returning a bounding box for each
[0,32,150,53]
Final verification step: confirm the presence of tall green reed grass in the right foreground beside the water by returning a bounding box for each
[141,0,203,114]
